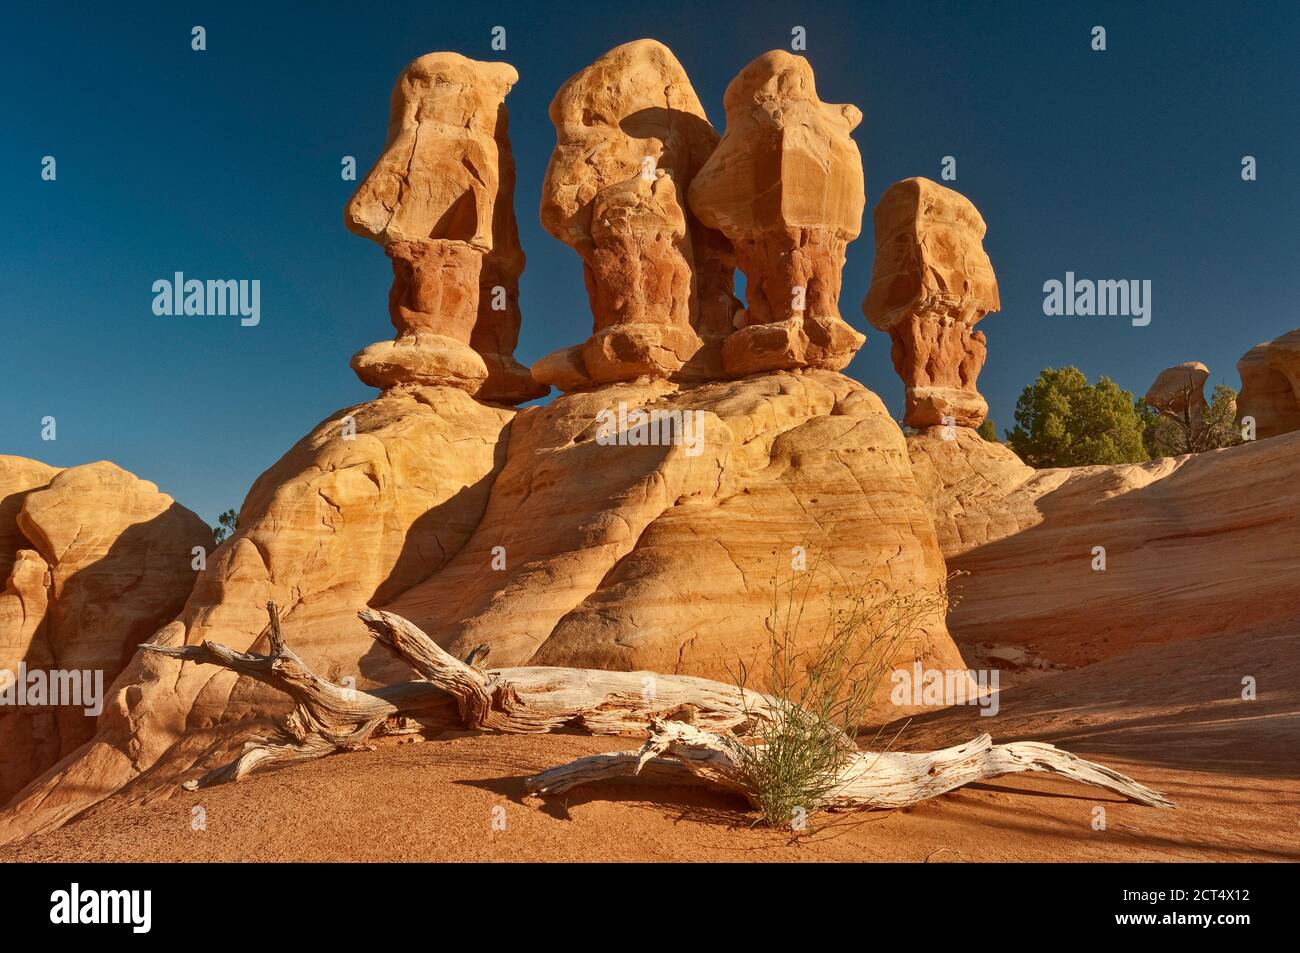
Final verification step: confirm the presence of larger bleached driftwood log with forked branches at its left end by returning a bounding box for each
[140,602,767,790]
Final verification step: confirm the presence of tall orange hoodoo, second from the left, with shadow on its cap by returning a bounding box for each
[533,40,738,390]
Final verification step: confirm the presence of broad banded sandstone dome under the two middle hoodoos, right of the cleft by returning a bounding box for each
[387,372,959,680]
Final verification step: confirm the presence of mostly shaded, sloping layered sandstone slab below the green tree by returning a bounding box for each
[909,429,1300,665]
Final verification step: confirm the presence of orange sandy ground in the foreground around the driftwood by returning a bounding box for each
[0,624,1300,862]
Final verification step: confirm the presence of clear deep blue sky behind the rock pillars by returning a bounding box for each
[0,0,1300,521]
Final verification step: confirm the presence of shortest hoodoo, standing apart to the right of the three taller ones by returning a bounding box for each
[862,178,1001,429]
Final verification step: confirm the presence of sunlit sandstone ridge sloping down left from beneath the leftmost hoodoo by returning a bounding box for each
[0,386,514,839]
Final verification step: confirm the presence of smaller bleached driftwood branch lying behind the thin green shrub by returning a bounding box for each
[524,720,1174,810]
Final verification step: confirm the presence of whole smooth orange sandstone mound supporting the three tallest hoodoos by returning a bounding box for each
[0,371,965,837]
